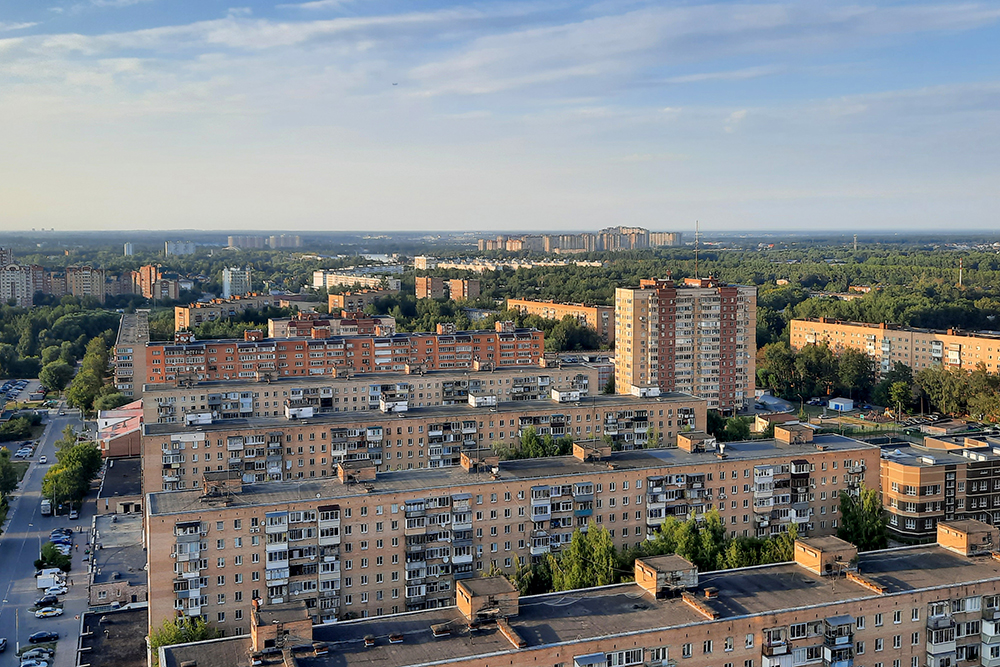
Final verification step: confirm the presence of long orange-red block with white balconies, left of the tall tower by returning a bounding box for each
[140,322,544,384]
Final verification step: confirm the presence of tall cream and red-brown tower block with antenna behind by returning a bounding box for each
[615,278,757,412]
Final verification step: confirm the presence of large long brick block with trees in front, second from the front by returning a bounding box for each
[147,434,876,636]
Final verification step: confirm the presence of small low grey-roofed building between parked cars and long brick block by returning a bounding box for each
[87,514,149,607]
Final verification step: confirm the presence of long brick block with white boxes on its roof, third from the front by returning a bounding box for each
[143,389,706,491]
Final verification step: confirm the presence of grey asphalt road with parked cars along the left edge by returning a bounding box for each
[0,410,94,667]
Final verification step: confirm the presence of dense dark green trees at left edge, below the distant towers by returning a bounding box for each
[0,297,121,377]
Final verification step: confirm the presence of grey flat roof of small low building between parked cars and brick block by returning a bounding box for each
[91,514,147,585]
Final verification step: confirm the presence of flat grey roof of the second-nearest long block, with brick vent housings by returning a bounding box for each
[148,434,877,516]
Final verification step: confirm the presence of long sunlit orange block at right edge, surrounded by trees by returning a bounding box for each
[789,317,1000,373]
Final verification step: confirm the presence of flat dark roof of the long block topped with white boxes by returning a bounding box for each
[142,392,704,438]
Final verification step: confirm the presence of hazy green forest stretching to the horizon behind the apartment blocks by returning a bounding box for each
[0,238,1000,418]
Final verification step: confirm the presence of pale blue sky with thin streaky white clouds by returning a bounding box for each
[0,0,1000,231]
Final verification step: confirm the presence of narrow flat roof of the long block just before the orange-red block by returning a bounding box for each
[137,362,598,396]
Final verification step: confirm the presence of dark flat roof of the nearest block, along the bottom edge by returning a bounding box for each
[166,545,1000,667]
